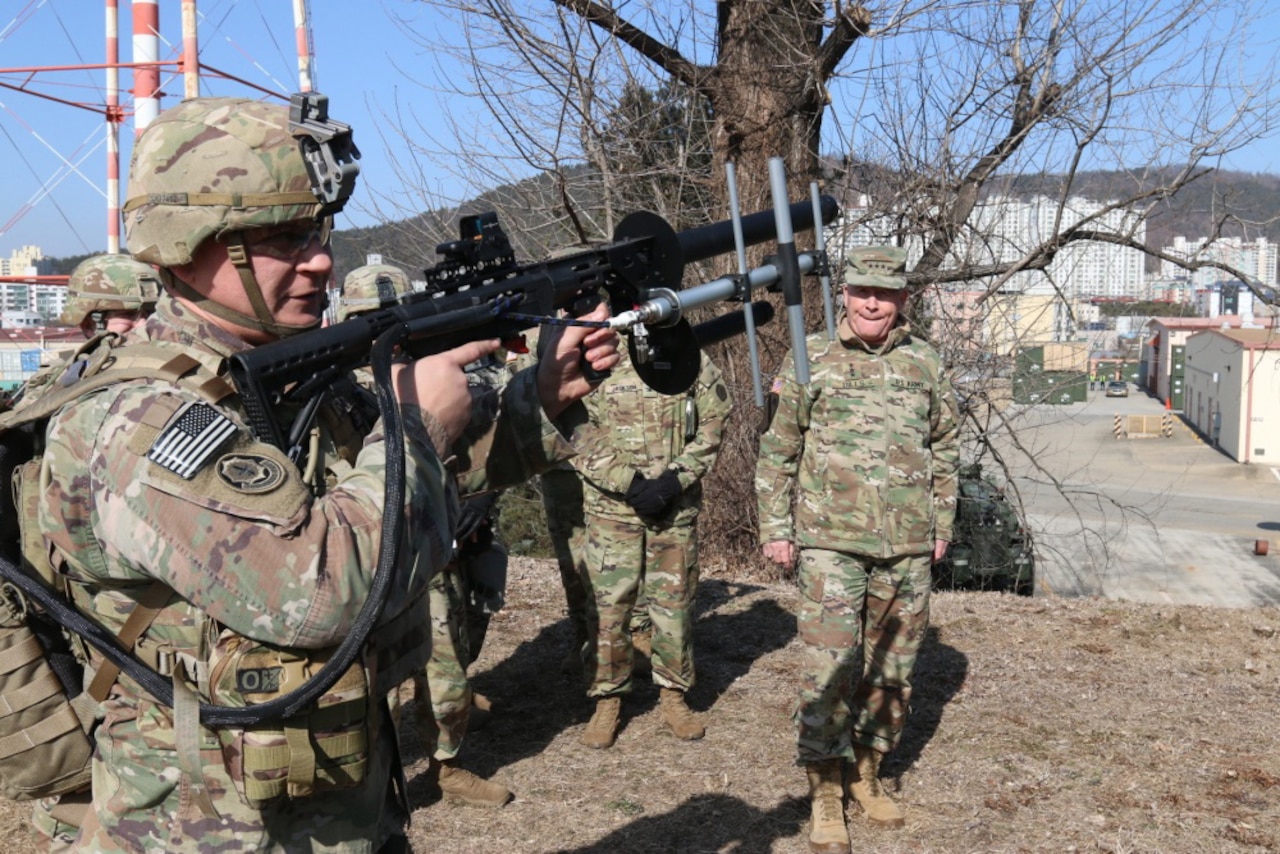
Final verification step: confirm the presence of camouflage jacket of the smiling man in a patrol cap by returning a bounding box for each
[755,319,960,557]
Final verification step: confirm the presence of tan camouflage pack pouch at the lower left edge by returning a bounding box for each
[0,584,93,800]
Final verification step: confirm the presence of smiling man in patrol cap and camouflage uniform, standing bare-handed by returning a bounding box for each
[755,247,959,851]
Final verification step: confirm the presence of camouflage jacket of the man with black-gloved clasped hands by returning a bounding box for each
[573,353,732,525]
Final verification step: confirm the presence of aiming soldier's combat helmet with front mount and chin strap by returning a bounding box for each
[124,93,360,335]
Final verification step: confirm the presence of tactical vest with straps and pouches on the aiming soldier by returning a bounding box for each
[0,332,417,816]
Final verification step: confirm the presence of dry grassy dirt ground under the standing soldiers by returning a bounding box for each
[0,558,1280,854]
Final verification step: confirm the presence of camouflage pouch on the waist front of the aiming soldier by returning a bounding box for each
[209,630,369,809]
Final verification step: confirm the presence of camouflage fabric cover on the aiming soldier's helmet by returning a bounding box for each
[124,97,323,266]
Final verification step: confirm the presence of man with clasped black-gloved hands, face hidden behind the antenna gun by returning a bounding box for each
[575,355,731,748]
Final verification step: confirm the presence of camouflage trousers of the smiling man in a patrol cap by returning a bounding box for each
[792,548,931,764]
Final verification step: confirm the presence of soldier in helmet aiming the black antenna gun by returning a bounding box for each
[24,99,617,851]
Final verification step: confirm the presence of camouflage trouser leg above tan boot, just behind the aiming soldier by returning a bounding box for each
[413,562,471,761]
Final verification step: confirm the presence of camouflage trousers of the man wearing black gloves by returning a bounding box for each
[584,507,698,698]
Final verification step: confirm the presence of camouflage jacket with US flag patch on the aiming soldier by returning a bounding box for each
[36,298,570,851]
